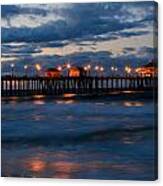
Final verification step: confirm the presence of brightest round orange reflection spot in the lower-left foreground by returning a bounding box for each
[27,159,46,172]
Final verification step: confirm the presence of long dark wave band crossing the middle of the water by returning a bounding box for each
[1,126,157,148]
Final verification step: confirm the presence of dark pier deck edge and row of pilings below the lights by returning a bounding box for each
[1,77,157,96]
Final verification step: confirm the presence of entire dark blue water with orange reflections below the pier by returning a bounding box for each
[1,92,157,180]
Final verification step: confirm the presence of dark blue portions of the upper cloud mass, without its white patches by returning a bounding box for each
[2,2,157,42]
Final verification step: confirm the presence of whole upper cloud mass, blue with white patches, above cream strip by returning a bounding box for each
[2,2,155,42]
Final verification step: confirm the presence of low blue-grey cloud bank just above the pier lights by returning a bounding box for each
[3,47,156,68]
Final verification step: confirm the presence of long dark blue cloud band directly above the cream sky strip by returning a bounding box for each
[2,17,141,42]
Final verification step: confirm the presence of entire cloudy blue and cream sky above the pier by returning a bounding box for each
[1,1,157,72]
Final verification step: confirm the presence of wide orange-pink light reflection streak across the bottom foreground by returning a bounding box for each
[21,155,143,178]
